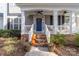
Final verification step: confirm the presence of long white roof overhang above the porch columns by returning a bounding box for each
[16,3,79,10]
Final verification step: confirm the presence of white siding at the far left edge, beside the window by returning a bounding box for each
[0,3,7,29]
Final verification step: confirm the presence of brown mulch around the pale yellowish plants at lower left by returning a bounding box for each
[0,38,26,56]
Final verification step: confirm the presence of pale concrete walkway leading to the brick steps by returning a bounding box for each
[25,47,57,56]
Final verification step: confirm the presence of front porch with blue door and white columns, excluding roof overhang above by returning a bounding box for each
[21,10,76,42]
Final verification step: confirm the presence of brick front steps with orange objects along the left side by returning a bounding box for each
[32,34,47,46]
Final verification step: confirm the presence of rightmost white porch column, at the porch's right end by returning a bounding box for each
[70,11,76,34]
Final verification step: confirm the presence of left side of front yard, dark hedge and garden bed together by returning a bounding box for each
[0,30,31,56]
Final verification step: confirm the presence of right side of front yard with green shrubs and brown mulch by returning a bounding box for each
[48,34,79,56]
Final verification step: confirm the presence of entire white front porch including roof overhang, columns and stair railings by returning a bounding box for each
[17,4,79,43]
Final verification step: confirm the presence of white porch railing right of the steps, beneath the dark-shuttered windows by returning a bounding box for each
[47,25,70,34]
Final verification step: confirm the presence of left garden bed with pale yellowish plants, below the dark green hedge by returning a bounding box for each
[0,38,31,56]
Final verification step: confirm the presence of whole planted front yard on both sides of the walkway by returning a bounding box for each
[0,30,79,56]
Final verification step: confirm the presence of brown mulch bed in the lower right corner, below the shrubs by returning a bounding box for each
[54,45,79,56]
